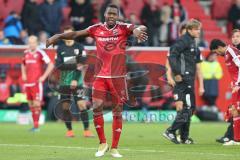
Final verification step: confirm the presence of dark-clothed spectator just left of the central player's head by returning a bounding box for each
[70,0,94,30]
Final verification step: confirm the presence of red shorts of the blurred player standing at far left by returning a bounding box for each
[25,83,43,101]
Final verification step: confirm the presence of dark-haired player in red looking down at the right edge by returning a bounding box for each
[210,39,240,146]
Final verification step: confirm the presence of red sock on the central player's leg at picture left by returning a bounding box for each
[93,114,106,143]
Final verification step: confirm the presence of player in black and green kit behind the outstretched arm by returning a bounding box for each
[55,26,94,137]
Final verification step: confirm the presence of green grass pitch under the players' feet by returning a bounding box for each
[0,122,240,160]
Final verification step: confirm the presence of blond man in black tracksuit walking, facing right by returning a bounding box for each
[163,19,204,144]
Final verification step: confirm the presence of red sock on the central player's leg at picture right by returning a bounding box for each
[112,113,122,148]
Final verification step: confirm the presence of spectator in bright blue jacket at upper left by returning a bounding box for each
[4,11,23,44]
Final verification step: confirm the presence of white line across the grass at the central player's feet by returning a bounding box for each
[0,144,240,157]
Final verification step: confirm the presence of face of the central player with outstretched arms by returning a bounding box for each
[104,7,119,28]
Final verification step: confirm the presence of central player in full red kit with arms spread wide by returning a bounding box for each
[47,4,148,158]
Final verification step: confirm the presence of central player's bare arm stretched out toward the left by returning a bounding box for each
[46,29,89,48]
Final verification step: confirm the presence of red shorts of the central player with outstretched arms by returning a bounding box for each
[92,77,128,105]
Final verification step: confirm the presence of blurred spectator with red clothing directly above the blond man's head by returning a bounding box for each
[171,0,188,22]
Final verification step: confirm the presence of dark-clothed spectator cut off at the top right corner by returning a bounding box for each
[228,0,240,29]
